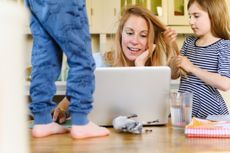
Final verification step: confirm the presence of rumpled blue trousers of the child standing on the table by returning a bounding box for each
[26,0,95,125]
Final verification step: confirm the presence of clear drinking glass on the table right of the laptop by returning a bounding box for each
[170,92,193,128]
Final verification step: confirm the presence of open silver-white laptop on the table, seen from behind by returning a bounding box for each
[89,66,171,126]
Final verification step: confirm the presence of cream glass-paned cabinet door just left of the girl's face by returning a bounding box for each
[168,0,189,25]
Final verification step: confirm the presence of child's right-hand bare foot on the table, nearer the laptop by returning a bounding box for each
[71,122,110,139]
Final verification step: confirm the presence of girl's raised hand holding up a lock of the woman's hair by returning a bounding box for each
[162,28,177,46]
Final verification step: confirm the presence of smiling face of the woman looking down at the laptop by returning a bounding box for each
[121,15,148,61]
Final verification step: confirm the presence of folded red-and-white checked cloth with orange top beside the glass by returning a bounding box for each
[185,117,230,138]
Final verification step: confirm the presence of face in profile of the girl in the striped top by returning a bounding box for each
[188,2,211,37]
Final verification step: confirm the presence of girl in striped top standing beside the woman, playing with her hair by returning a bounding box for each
[173,0,230,118]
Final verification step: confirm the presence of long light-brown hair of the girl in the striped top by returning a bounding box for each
[187,0,230,39]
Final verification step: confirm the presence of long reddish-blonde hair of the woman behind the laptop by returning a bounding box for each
[105,6,179,66]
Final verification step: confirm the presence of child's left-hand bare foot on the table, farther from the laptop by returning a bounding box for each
[32,122,69,138]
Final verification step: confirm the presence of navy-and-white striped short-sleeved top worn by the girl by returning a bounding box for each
[179,36,230,118]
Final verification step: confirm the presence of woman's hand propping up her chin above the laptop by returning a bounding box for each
[135,44,156,66]
